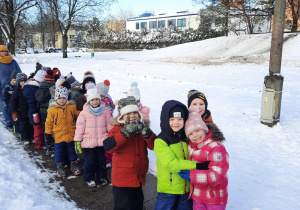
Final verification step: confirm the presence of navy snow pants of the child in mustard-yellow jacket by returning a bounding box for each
[54,141,77,164]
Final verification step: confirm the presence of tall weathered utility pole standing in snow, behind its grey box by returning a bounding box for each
[261,0,286,127]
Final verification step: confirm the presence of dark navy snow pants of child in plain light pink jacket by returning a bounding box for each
[82,147,106,182]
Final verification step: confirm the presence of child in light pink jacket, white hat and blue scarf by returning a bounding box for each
[74,87,112,187]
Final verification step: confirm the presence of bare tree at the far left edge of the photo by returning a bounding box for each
[0,0,37,54]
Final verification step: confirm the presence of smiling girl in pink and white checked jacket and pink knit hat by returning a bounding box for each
[179,106,229,210]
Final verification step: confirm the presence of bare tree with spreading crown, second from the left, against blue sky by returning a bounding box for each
[45,0,115,58]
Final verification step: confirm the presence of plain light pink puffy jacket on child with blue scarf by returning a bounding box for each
[74,103,113,148]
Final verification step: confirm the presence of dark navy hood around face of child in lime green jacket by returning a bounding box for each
[160,100,189,139]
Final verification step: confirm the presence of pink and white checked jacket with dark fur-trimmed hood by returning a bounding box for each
[189,127,229,204]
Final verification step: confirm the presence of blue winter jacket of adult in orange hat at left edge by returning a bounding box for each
[0,59,22,100]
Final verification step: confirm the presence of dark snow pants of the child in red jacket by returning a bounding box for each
[112,186,144,210]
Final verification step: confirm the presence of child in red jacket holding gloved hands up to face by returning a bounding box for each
[103,97,156,210]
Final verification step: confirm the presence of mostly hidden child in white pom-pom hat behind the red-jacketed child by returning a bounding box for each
[126,82,150,127]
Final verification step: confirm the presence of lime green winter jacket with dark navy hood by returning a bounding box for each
[154,100,196,195]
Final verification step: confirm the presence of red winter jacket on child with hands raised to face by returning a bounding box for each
[103,117,156,187]
